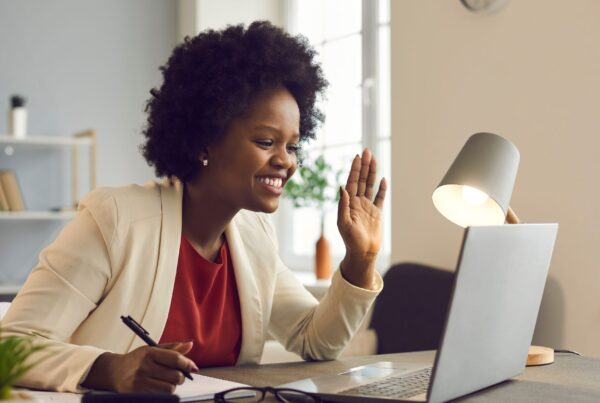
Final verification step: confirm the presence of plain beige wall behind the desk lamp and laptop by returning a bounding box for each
[391,0,600,356]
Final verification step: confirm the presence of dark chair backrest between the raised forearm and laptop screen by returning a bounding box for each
[370,263,454,354]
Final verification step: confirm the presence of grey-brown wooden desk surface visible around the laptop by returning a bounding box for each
[201,351,600,403]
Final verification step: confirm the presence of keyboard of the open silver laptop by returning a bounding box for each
[341,368,431,399]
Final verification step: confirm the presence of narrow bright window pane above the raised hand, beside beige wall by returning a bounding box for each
[377,26,392,137]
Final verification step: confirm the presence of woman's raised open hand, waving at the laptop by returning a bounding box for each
[337,149,387,289]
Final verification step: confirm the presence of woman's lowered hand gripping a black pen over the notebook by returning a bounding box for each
[82,341,198,393]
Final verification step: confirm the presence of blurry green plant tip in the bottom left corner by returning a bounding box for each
[0,329,46,400]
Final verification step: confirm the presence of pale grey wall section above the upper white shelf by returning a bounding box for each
[0,0,177,185]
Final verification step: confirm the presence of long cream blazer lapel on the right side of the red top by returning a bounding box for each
[225,219,264,365]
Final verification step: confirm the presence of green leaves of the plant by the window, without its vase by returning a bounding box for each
[284,155,342,224]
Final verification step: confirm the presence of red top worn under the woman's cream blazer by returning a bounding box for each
[160,236,242,368]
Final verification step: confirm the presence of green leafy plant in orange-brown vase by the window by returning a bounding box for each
[284,155,342,279]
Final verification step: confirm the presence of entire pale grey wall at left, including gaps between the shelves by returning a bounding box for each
[0,0,177,292]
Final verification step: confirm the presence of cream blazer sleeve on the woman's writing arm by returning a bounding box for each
[2,191,116,392]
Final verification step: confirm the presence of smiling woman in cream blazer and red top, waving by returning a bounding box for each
[3,22,386,392]
